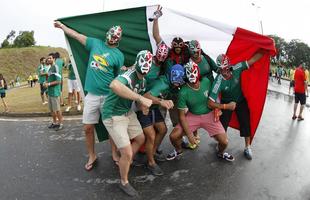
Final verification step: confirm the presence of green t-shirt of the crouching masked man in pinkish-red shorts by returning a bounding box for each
[178,77,211,115]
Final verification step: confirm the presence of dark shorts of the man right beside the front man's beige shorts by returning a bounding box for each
[136,108,165,128]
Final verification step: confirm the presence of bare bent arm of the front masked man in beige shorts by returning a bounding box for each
[110,79,152,108]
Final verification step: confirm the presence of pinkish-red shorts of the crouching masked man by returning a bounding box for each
[176,111,225,137]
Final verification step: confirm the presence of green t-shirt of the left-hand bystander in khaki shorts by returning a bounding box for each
[47,65,61,97]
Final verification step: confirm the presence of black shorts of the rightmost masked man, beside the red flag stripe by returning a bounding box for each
[220,99,251,137]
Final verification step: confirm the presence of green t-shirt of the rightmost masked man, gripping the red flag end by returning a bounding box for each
[209,62,248,103]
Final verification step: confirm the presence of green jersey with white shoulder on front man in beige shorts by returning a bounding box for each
[101,69,146,119]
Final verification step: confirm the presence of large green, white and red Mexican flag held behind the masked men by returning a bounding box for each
[59,6,275,141]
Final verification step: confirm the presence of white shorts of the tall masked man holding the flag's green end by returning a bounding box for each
[83,93,105,124]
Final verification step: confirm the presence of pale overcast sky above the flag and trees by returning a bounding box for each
[0,0,310,47]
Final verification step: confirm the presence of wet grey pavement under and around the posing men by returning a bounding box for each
[0,81,310,200]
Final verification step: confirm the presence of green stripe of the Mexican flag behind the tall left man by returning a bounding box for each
[59,7,152,141]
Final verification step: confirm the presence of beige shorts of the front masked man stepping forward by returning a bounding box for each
[102,111,143,148]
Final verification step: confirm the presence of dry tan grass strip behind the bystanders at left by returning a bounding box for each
[0,76,83,113]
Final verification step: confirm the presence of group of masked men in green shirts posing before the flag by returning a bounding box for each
[53,9,270,196]
